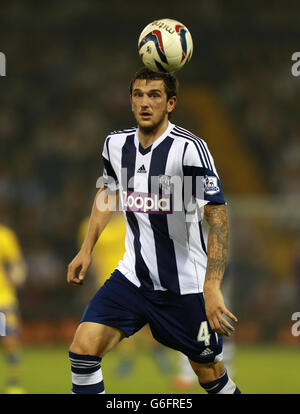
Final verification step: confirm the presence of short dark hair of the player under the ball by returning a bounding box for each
[130,67,179,100]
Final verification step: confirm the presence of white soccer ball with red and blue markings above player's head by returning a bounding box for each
[138,19,193,72]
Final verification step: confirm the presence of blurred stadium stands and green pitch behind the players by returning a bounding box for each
[0,0,300,393]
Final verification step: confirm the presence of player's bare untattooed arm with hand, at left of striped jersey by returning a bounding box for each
[67,187,119,286]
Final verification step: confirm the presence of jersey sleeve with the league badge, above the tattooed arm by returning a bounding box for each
[183,139,226,206]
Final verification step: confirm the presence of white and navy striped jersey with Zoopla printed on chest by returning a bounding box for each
[102,122,225,295]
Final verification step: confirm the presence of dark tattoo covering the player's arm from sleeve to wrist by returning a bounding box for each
[204,204,229,281]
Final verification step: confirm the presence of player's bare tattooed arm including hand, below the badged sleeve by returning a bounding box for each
[203,204,237,336]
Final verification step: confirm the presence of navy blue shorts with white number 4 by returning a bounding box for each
[81,270,222,363]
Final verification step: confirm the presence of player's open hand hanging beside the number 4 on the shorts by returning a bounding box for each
[204,285,237,336]
